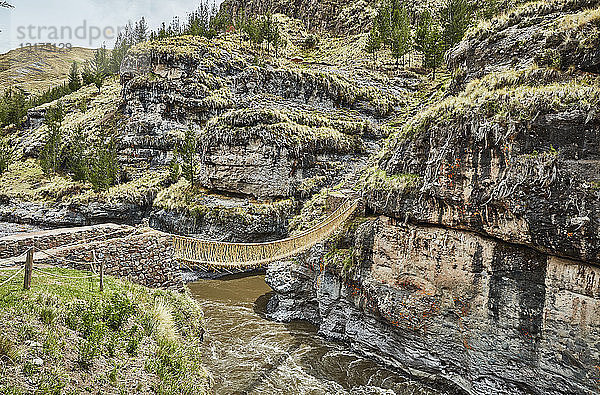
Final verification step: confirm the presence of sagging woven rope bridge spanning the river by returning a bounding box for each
[173,200,358,269]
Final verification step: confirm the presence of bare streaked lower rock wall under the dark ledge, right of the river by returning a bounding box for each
[267,217,600,394]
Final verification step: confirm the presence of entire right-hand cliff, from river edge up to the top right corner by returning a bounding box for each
[267,2,600,394]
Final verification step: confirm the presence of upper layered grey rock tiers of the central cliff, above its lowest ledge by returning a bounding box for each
[121,37,386,199]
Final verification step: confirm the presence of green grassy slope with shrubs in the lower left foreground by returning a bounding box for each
[0,269,208,394]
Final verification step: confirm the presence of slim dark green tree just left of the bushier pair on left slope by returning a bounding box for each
[40,102,65,174]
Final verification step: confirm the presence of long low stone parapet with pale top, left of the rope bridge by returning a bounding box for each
[0,224,134,259]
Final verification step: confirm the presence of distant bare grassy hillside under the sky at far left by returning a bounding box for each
[0,47,94,93]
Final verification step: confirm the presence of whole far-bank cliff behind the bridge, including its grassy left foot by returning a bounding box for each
[0,25,398,241]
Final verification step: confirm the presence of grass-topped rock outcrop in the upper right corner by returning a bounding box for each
[447,0,600,84]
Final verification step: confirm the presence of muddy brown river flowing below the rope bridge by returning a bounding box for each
[189,276,438,395]
